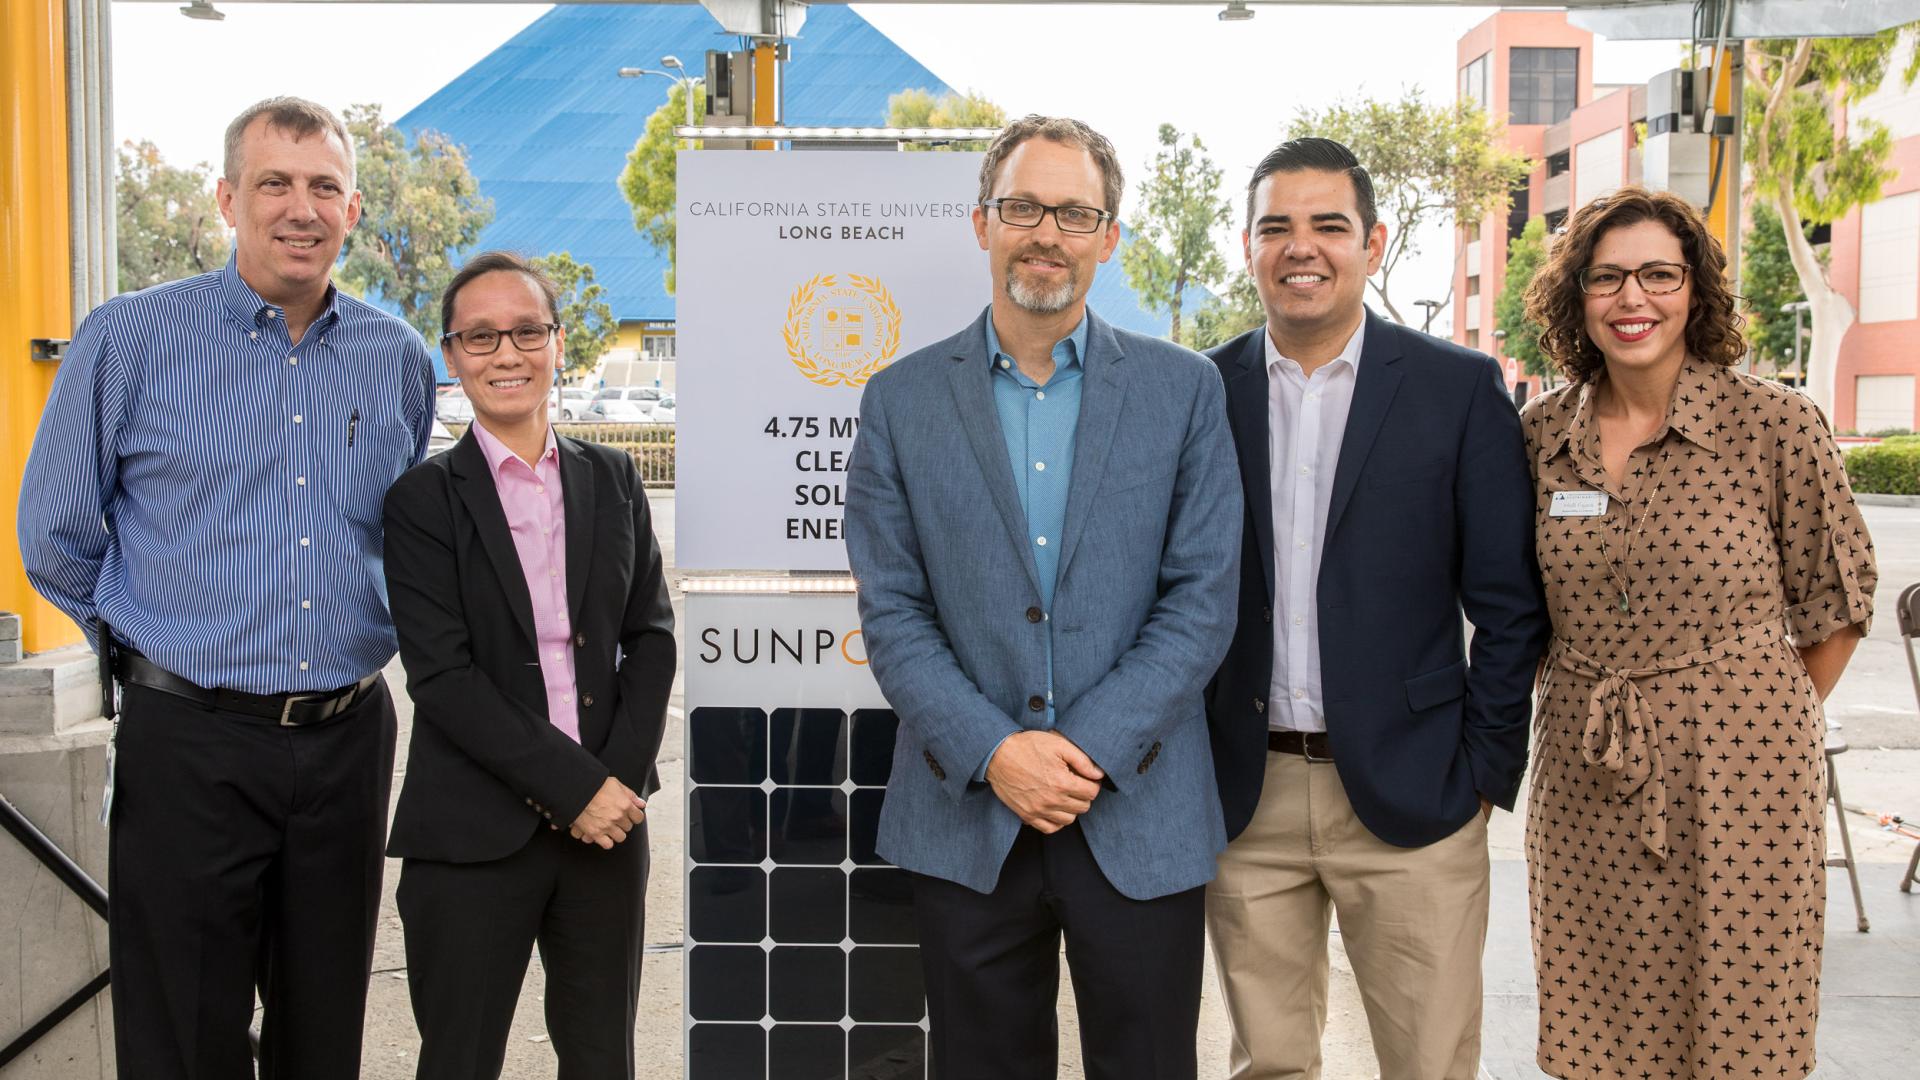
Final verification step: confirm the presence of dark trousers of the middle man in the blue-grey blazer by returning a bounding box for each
[914,824,1206,1080]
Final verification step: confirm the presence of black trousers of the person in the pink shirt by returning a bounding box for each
[399,824,647,1080]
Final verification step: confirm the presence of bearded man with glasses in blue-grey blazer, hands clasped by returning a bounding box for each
[847,117,1240,1080]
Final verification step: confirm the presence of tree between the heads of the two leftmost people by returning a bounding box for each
[336,106,493,340]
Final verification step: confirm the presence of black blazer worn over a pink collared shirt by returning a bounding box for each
[386,430,674,863]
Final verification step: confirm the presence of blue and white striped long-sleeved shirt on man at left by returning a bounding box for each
[19,261,434,694]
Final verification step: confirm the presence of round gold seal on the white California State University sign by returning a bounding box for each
[781,273,900,386]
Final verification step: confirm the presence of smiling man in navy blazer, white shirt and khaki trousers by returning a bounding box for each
[1208,138,1548,1080]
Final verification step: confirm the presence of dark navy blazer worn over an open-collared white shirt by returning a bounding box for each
[1208,311,1548,847]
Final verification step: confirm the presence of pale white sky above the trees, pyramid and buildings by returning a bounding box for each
[113,0,1680,331]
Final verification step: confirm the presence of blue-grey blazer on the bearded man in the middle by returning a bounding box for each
[847,311,1242,899]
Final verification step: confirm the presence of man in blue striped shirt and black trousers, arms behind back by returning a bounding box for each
[19,98,432,1080]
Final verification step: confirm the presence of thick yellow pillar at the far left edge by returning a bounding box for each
[0,0,81,651]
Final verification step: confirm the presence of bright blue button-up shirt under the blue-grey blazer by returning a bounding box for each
[973,315,1087,780]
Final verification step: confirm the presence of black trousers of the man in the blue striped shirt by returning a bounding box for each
[108,680,394,1080]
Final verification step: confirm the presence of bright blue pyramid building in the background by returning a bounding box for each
[396,4,1210,368]
